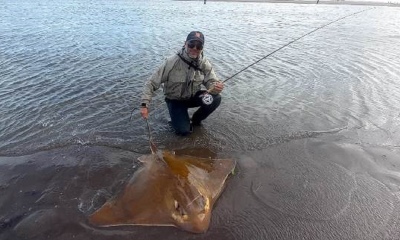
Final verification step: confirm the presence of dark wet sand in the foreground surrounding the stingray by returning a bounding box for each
[0,135,400,240]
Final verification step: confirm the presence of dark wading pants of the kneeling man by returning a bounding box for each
[165,91,221,135]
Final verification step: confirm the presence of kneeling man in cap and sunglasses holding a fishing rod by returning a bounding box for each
[140,31,224,135]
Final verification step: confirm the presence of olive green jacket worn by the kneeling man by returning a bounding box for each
[142,48,219,105]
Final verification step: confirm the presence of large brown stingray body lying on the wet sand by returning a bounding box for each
[89,151,236,233]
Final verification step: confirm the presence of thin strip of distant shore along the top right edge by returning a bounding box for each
[177,0,400,7]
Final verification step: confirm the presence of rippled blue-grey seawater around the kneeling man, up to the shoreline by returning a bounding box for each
[0,0,400,156]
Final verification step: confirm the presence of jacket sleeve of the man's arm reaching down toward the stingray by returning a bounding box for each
[141,61,167,105]
